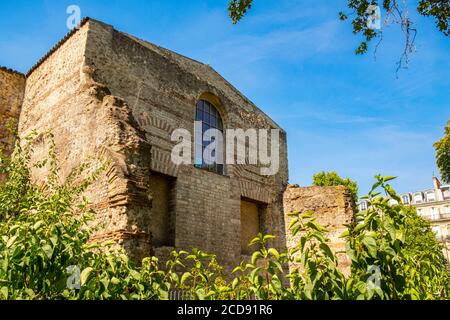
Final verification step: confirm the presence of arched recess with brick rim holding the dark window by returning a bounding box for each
[194,92,226,175]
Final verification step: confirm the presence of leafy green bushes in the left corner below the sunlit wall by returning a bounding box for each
[0,134,168,299]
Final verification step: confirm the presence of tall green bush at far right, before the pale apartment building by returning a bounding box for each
[345,176,449,299]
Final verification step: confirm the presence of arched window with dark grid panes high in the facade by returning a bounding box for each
[195,100,224,174]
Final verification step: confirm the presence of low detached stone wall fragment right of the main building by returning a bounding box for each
[284,185,355,274]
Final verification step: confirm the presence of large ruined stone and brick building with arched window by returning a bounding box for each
[0,18,353,272]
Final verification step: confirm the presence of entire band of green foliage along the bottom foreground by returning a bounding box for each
[0,131,450,300]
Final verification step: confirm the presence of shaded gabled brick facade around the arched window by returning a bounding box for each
[86,20,288,263]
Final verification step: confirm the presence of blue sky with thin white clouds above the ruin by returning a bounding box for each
[0,0,450,194]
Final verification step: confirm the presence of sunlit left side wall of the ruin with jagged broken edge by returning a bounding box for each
[19,23,151,258]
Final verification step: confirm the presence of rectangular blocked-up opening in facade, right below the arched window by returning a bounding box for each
[241,199,267,255]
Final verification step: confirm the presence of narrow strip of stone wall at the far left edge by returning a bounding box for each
[0,67,25,179]
